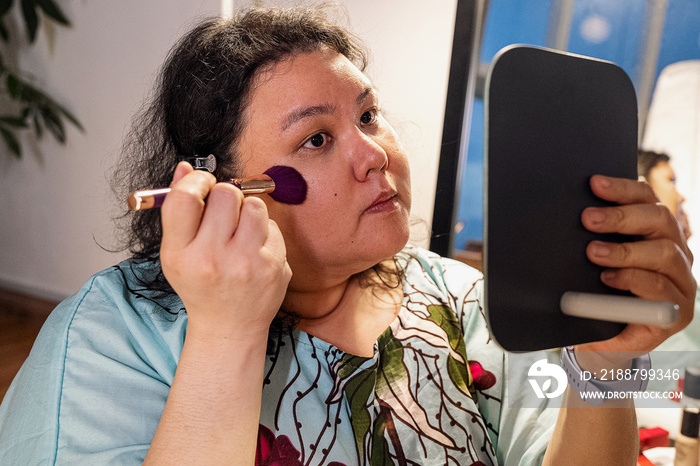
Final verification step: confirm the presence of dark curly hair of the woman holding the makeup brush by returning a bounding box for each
[112,6,368,294]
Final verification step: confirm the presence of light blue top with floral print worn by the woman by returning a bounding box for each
[0,248,557,466]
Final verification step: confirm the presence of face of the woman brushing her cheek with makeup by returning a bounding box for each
[237,51,411,290]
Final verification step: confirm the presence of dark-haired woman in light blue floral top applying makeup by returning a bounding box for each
[0,5,695,465]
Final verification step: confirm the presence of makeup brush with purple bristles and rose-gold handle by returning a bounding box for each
[127,165,306,210]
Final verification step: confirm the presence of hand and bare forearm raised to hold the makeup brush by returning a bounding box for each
[146,162,292,463]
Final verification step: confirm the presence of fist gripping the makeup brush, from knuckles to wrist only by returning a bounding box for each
[160,163,291,340]
